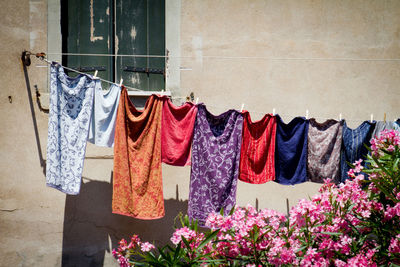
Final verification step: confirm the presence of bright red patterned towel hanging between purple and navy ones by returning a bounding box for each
[239,111,276,184]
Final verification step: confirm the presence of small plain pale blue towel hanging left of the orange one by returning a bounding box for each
[88,83,121,147]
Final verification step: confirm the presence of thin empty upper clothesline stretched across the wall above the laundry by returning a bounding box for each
[47,53,400,62]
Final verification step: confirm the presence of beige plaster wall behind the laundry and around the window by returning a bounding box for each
[0,0,400,266]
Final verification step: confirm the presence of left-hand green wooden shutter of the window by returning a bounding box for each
[62,0,114,80]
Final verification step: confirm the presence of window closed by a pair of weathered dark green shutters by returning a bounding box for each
[61,0,165,91]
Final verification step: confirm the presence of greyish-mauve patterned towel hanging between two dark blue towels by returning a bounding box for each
[307,119,343,183]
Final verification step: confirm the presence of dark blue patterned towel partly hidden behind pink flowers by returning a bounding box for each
[340,121,375,182]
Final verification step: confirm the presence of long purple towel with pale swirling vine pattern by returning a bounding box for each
[188,104,243,225]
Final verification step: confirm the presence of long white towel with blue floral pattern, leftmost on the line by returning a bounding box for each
[46,65,96,195]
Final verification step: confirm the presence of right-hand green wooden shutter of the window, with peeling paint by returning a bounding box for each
[115,0,165,91]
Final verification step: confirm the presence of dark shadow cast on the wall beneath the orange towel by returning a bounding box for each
[62,175,187,266]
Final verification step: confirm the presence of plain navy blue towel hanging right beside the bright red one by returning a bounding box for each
[275,115,308,185]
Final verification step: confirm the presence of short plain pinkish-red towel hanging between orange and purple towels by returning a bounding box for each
[161,99,197,166]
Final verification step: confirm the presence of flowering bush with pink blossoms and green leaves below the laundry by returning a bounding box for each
[113,131,400,266]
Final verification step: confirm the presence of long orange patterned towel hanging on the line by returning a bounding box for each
[112,88,165,220]
